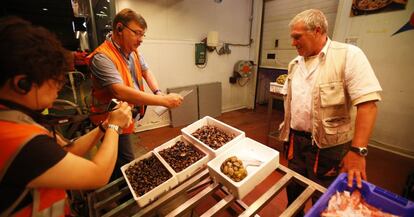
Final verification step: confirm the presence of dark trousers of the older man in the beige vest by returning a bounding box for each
[286,130,350,216]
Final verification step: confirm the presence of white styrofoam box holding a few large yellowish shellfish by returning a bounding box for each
[207,138,279,199]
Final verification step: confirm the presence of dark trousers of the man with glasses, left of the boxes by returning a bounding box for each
[109,134,135,182]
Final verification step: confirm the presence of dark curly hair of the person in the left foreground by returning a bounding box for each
[0,16,73,86]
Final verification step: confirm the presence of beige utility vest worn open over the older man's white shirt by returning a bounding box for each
[279,41,354,148]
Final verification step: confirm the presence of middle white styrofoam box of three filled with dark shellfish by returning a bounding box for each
[153,135,209,183]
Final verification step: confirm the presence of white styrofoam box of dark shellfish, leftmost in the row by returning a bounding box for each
[121,151,178,207]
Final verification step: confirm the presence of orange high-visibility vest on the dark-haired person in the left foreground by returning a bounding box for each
[0,109,70,217]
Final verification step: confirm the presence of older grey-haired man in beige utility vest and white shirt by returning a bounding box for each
[280,9,382,215]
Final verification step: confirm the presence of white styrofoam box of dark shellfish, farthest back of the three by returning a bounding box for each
[181,116,245,159]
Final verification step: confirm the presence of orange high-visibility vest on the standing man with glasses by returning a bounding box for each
[88,40,145,133]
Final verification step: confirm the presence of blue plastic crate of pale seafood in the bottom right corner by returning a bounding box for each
[305,173,414,217]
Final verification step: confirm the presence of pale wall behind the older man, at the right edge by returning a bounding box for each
[334,0,414,156]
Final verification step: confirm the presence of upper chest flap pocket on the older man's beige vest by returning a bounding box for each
[319,81,345,108]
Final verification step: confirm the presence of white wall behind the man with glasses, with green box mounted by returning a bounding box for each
[116,0,263,130]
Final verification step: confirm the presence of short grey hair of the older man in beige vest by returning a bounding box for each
[289,9,328,33]
